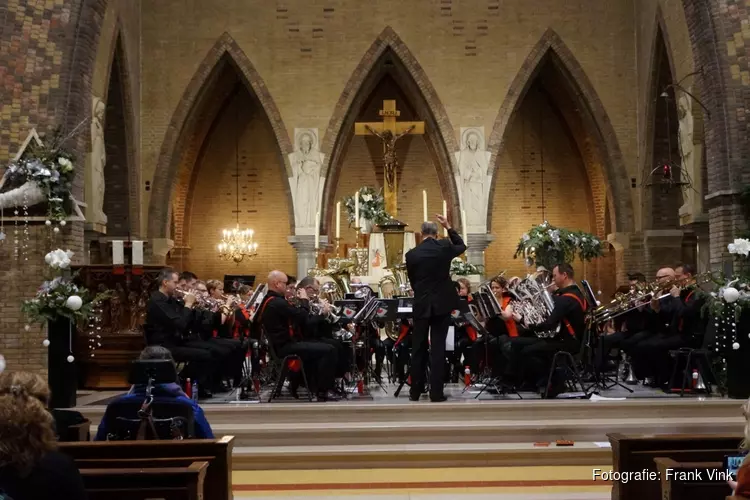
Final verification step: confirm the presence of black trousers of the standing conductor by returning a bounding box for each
[410,314,451,399]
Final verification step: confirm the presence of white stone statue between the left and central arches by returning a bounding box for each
[289,128,325,234]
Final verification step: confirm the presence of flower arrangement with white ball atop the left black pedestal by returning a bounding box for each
[21,249,108,324]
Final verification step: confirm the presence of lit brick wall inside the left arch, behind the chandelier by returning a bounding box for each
[176,87,296,279]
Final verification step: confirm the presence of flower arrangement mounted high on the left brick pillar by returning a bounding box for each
[2,132,75,225]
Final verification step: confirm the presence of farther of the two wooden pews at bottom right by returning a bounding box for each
[607,433,742,500]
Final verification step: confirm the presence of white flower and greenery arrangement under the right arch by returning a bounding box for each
[513,221,604,270]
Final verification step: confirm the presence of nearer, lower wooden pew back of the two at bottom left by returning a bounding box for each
[80,462,208,500]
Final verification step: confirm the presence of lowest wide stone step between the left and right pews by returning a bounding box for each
[232,442,612,470]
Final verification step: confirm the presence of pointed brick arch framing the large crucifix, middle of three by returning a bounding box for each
[321,26,458,232]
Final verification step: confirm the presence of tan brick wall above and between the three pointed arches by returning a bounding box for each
[141,0,636,246]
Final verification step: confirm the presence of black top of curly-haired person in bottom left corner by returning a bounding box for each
[0,451,88,500]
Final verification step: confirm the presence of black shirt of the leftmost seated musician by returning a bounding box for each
[144,290,193,345]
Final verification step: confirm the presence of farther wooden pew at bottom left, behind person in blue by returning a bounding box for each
[60,436,234,500]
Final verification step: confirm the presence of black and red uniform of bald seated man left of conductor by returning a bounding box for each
[257,290,338,393]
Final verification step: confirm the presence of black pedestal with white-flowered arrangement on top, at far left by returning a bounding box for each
[21,249,108,408]
